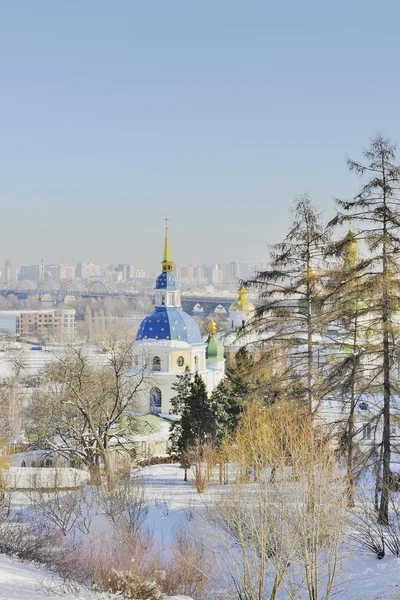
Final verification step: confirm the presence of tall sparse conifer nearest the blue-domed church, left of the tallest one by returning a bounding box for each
[252,195,327,413]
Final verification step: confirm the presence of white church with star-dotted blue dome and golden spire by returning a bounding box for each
[128,228,225,416]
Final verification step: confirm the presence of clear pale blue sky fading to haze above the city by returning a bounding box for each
[0,0,400,268]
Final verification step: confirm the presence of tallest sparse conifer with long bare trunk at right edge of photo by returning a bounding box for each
[331,135,400,524]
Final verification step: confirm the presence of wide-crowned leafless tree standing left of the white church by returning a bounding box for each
[37,343,145,489]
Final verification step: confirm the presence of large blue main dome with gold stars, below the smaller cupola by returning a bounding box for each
[136,306,203,344]
